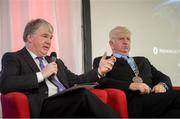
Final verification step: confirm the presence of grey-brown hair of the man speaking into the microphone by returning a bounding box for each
[23,18,54,42]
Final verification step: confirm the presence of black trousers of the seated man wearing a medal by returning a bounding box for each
[129,91,180,118]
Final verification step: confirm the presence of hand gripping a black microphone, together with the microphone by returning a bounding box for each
[41,52,57,78]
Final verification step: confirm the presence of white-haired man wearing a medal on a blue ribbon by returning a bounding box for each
[93,26,180,117]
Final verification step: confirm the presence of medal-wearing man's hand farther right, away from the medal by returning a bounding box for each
[151,83,166,93]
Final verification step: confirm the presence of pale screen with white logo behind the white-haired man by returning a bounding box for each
[91,0,180,85]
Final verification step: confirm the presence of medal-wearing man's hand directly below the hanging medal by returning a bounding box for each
[129,83,151,94]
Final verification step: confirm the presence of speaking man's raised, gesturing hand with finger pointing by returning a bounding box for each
[98,52,116,76]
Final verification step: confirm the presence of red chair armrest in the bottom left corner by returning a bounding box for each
[1,92,30,118]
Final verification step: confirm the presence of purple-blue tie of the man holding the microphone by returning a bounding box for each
[37,57,65,92]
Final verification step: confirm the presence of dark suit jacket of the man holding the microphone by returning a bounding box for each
[0,48,99,117]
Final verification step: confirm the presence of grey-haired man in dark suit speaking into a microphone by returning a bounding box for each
[0,19,118,118]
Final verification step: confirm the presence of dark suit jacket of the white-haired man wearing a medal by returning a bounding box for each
[93,57,172,95]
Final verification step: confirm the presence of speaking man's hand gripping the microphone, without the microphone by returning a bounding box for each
[41,62,57,79]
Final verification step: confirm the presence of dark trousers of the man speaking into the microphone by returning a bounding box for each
[40,89,118,118]
